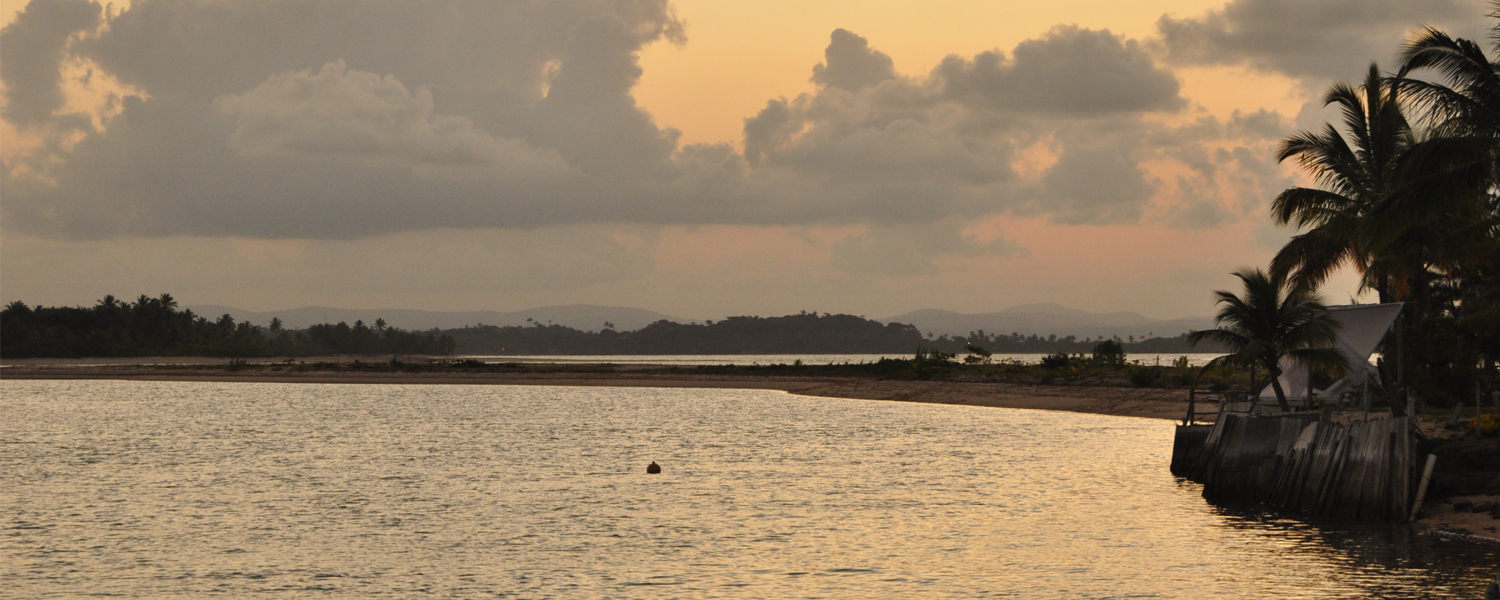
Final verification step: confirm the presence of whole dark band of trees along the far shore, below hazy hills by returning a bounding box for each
[0,300,1218,359]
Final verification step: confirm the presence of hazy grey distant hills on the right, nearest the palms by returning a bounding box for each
[881,303,1214,338]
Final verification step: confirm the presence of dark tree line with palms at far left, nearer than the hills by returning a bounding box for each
[0,294,453,359]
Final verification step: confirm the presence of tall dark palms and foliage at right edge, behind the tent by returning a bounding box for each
[1221,7,1500,416]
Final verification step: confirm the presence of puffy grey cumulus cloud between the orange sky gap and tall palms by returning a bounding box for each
[744,27,1287,228]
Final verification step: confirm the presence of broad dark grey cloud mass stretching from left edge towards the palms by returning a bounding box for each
[0,0,1284,241]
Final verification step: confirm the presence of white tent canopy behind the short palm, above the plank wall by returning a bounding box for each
[1260,302,1403,402]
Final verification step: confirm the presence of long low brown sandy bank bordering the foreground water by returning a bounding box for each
[0,363,1188,420]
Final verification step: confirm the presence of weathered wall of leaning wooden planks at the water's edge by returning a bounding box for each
[1172,404,1419,521]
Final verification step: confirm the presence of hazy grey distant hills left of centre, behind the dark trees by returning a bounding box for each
[188,305,689,332]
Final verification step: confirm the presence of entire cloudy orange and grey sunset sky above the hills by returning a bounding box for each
[0,0,1485,318]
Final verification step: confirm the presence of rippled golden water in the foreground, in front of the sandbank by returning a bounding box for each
[0,381,1500,599]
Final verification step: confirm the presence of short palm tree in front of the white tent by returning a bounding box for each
[1188,269,1349,413]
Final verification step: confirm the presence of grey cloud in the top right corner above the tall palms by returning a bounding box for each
[1157,0,1485,81]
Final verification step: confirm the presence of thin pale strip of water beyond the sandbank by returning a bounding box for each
[459,353,1223,366]
